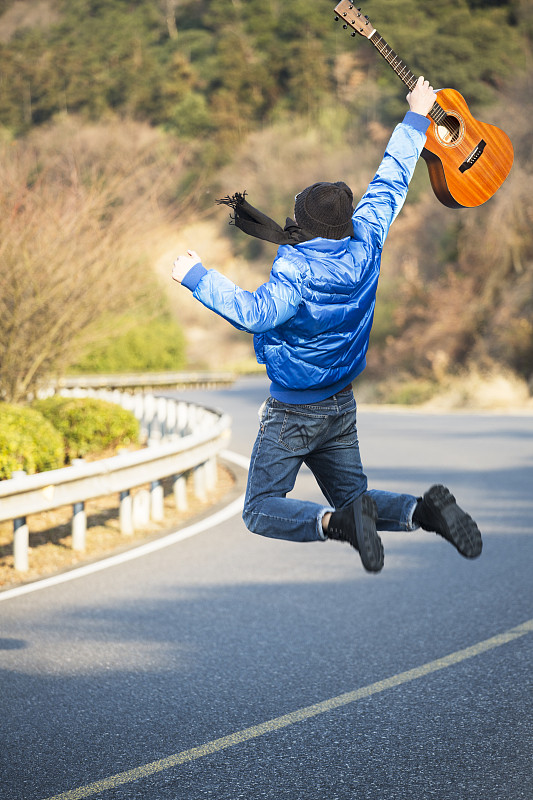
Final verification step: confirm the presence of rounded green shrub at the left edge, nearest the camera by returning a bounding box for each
[0,403,65,480]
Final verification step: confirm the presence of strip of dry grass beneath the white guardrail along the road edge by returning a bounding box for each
[0,465,235,589]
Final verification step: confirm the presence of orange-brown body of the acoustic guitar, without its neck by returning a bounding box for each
[422,89,513,208]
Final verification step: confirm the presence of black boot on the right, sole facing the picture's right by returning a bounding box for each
[413,485,483,558]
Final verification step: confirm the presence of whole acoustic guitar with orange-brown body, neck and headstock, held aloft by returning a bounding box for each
[335,0,513,208]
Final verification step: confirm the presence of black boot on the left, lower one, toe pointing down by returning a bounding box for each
[326,494,384,572]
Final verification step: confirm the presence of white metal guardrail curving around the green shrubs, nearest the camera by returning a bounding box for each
[0,389,231,572]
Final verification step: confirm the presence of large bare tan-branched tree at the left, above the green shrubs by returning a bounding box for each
[0,114,190,402]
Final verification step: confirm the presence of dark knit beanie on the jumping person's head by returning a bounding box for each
[294,181,354,239]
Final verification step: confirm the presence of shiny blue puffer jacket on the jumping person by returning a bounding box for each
[183,111,429,403]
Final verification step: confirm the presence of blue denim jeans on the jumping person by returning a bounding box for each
[243,392,417,542]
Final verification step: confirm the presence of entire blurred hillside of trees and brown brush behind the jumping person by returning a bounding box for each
[0,0,533,399]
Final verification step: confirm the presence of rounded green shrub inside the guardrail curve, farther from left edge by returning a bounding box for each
[33,395,139,460]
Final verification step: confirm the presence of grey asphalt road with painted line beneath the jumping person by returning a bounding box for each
[0,379,533,800]
